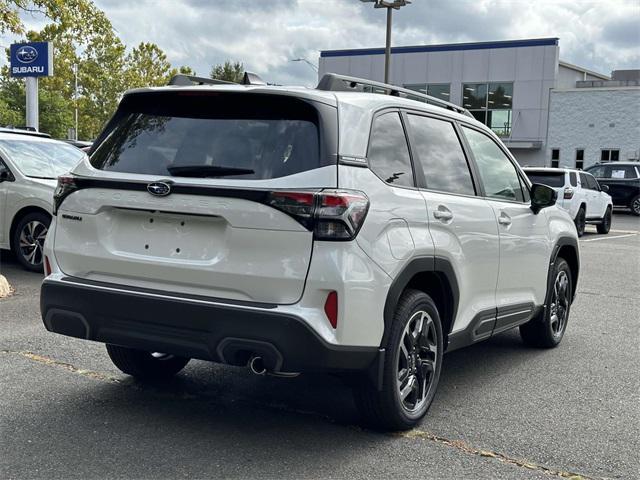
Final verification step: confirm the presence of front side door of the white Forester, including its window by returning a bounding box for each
[463,126,551,333]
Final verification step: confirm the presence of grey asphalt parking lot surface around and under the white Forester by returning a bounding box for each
[0,213,640,479]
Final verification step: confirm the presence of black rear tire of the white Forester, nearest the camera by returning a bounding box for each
[354,290,444,430]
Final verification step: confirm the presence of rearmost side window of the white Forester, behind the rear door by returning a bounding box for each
[367,112,414,187]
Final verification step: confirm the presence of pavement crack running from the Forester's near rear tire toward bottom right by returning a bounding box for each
[394,429,593,480]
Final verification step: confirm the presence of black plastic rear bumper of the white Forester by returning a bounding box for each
[40,278,379,372]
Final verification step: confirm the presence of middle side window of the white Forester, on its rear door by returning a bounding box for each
[409,115,476,195]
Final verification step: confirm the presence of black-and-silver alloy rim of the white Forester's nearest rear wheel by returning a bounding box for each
[396,311,438,412]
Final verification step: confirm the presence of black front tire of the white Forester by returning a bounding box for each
[520,257,573,348]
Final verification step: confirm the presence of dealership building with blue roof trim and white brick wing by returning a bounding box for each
[319,38,640,168]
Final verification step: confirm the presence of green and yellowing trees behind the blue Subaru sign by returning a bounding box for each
[0,0,200,139]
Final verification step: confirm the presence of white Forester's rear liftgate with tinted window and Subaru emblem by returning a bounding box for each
[54,90,337,304]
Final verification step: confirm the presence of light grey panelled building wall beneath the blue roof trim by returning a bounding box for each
[319,45,559,165]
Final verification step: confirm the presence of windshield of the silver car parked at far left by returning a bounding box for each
[0,140,84,179]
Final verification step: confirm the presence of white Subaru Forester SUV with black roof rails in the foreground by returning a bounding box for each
[41,75,579,429]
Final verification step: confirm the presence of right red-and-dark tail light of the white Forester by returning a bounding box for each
[267,190,369,241]
